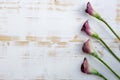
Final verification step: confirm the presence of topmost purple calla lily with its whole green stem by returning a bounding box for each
[85,2,120,40]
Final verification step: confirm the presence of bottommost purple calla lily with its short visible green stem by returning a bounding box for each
[81,58,107,80]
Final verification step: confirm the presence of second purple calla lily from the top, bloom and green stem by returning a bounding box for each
[81,21,120,62]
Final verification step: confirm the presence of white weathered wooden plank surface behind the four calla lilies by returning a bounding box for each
[0,0,120,80]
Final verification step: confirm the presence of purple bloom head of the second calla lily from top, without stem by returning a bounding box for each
[81,20,98,38]
